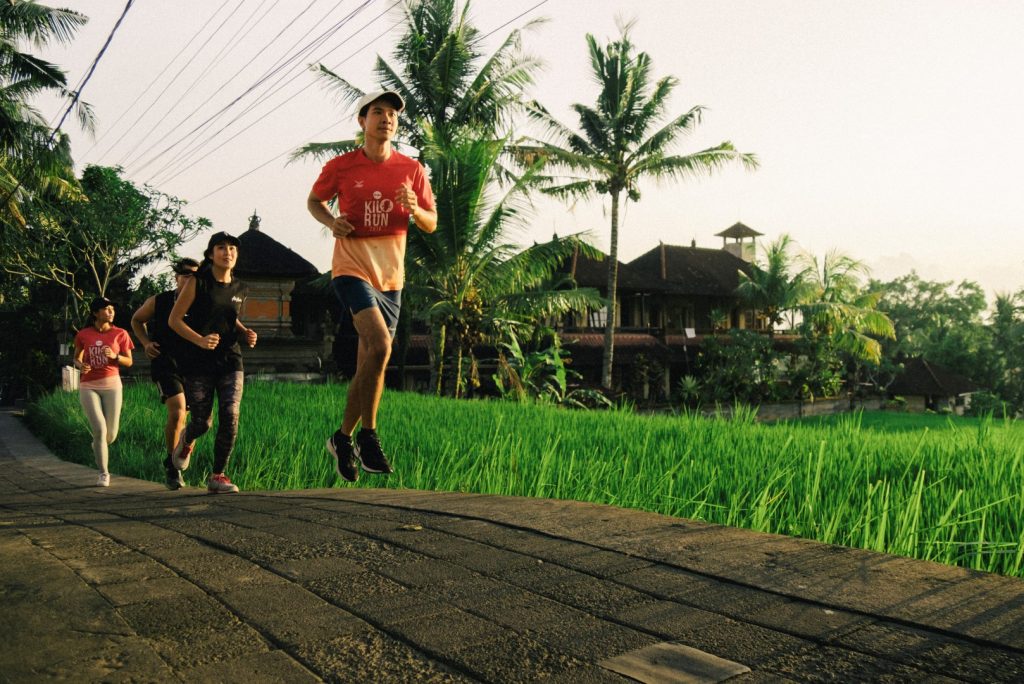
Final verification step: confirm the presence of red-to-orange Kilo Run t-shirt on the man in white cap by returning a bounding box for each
[312,148,434,292]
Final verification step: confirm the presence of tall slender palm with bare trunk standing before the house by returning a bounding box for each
[520,24,757,389]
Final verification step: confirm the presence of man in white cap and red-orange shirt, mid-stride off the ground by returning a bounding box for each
[306,90,437,482]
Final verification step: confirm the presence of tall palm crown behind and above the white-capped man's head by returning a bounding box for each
[293,0,541,162]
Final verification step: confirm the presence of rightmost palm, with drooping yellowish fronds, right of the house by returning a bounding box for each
[801,250,895,364]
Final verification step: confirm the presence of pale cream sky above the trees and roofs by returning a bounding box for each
[40,0,1024,295]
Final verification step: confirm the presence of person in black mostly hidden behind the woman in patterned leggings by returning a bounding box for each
[131,254,199,489]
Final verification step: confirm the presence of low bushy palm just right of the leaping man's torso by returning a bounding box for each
[407,134,600,396]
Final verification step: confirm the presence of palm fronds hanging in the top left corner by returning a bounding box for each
[0,0,93,229]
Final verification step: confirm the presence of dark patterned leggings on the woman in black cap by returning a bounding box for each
[184,371,244,473]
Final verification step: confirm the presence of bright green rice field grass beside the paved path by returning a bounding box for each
[29,382,1024,576]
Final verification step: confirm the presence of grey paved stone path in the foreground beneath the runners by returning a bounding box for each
[0,414,1024,684]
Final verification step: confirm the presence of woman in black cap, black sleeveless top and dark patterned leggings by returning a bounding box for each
[169,232,256,494]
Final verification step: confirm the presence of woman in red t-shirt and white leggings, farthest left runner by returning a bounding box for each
[75,297,135,486]
